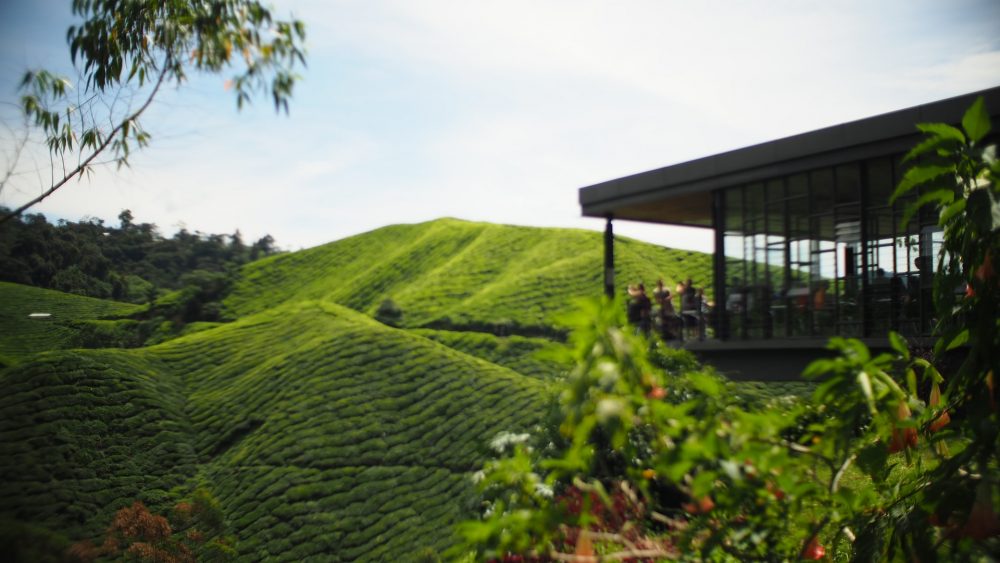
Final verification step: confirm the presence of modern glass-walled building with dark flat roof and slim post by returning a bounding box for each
[580,87,1000,377]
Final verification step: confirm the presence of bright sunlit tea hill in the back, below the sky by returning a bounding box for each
[226,219,711,334]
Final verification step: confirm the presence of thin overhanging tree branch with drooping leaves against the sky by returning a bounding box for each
[0,0,305,223]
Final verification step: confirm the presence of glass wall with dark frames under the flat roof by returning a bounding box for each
[716,154,940,339]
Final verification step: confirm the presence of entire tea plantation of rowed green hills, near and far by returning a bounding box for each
[0,220,720,561]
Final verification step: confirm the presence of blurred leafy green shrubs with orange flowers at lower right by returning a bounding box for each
[453,100,1000,561]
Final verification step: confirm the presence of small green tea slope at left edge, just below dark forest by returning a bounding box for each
[0,282,141,366]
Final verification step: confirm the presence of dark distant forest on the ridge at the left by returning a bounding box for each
[0,208,279,303]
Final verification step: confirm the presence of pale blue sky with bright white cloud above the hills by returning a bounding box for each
[0,0,1000,251]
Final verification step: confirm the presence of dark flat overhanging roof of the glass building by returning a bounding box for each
[580,86,1000,227]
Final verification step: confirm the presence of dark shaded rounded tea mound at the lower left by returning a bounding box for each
[0,350,197,539]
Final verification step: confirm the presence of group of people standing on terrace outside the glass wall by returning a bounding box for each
[626,278,709,340]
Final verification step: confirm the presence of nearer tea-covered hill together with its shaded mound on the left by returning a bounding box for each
[0,301,546,561]
